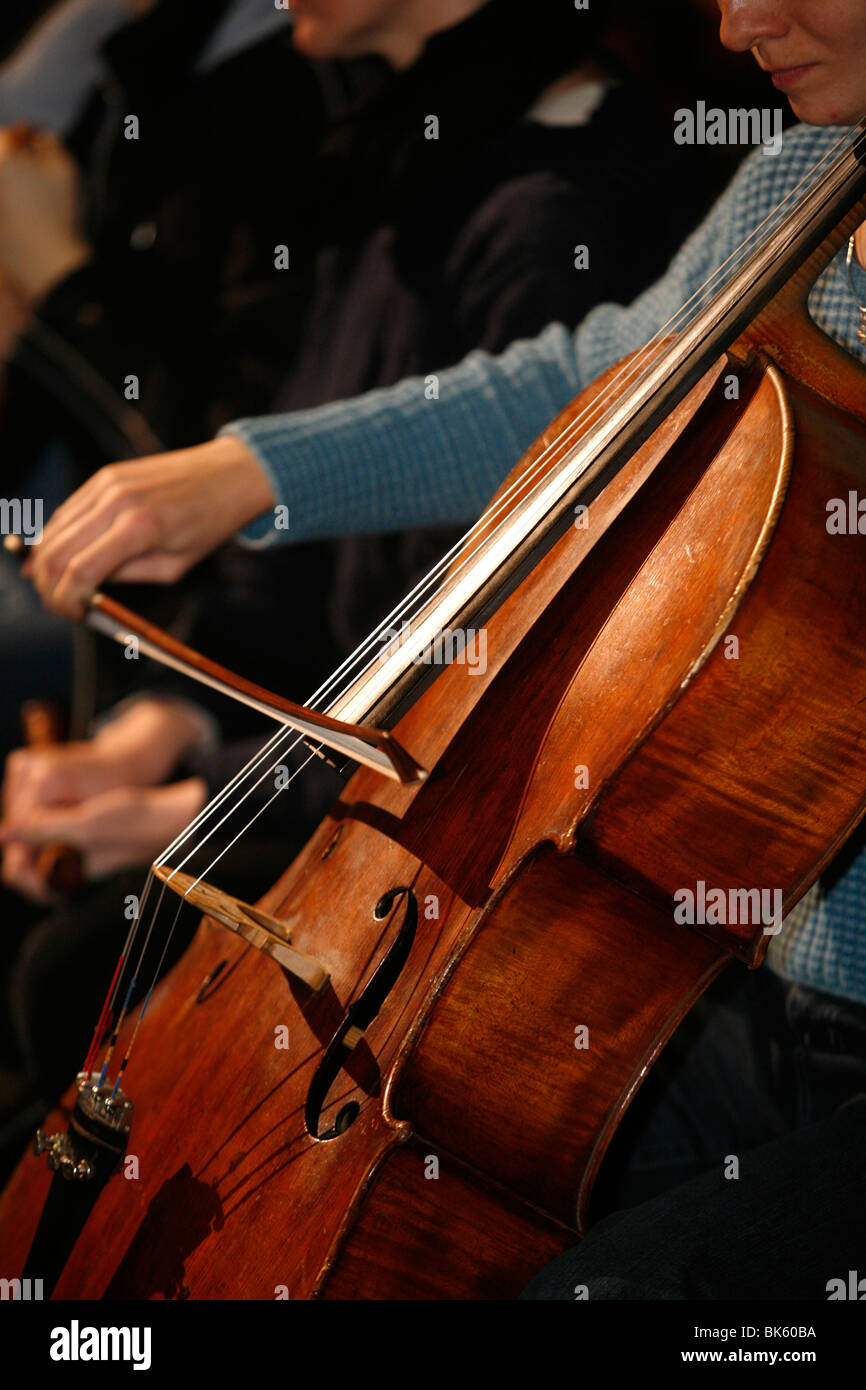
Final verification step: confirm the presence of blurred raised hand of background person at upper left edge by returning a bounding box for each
[0,125,92,304]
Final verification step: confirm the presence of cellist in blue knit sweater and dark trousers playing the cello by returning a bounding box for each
[13,0,866,1298]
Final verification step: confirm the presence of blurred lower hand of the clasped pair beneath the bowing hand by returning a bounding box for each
[0,777,207,905]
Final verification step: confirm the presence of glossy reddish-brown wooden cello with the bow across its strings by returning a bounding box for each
[0,122,866,1298]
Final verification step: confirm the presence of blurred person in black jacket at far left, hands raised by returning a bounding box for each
[0,0,335,749]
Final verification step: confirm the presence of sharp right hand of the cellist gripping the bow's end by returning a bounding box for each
[24,435,274,619]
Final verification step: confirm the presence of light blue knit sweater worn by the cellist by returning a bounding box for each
[227,125,866,1004]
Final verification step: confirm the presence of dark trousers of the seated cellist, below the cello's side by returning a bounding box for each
[523,969,866,1300]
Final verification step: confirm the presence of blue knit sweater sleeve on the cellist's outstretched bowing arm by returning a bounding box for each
[222,138,801,548]
